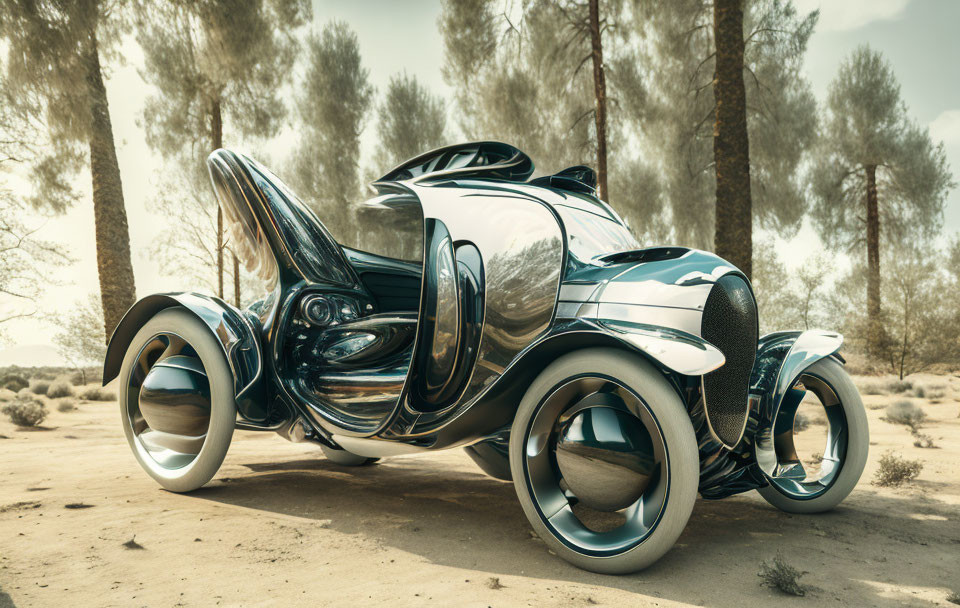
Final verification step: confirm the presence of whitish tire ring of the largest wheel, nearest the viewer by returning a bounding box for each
[510,348,700,574]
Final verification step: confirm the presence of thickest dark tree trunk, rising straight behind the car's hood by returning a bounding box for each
[713,0,753,277]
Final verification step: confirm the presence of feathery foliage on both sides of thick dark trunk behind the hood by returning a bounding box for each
[631,0,818,248]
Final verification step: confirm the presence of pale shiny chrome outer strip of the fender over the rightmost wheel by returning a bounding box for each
[754,329,843,475]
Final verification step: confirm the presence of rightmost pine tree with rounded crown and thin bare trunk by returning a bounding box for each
[811,46,954,356]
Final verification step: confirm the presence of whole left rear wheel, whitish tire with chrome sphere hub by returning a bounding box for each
[119,308,237,492]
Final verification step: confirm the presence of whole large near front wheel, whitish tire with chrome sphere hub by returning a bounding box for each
[510,349,699,574]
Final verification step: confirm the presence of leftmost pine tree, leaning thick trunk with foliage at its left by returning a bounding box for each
[0,0,136,336]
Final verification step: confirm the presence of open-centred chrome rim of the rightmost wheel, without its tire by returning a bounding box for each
[769,374,849,500]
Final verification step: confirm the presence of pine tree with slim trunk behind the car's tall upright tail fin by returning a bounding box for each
[137,0,311,306]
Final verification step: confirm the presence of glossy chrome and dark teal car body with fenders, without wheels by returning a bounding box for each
[104,142,856,568]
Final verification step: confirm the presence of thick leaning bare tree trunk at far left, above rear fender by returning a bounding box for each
[83,32,137,340]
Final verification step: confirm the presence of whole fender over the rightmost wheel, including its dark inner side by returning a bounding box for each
[750,329,843,475]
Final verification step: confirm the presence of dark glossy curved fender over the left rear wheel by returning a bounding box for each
[103,292,269,422]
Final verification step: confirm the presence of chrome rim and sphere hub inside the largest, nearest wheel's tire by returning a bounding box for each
[523,375,670,557]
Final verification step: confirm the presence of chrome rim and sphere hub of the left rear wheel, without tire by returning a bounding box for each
[125,332,211,476]
